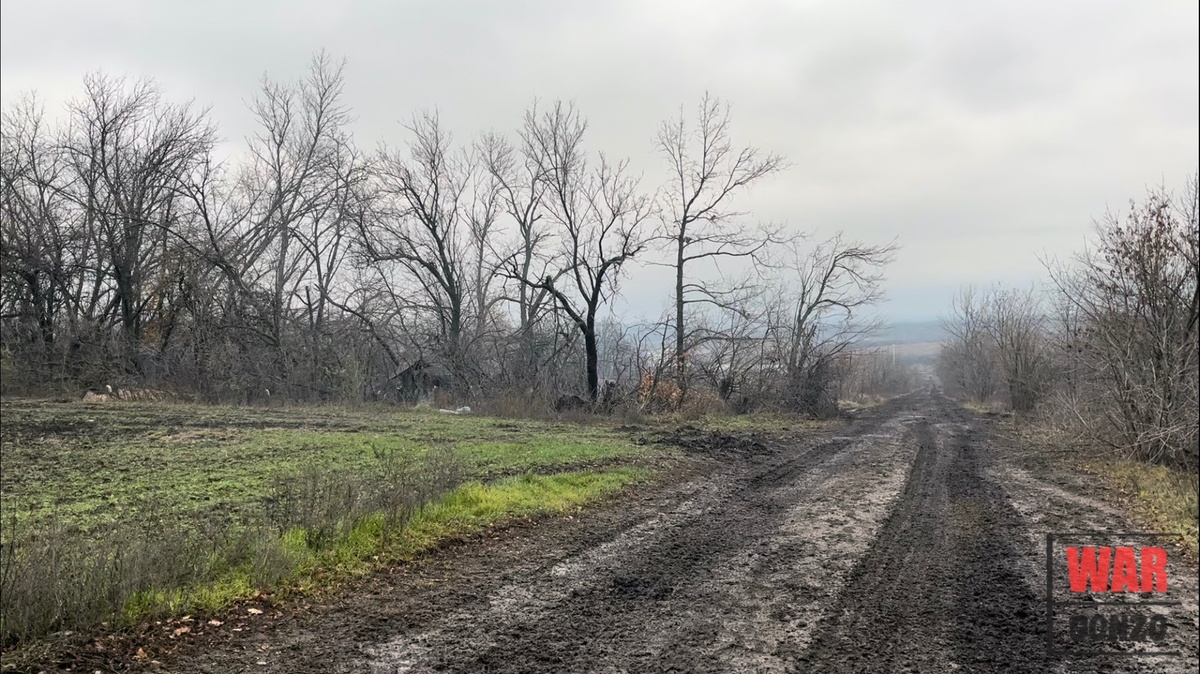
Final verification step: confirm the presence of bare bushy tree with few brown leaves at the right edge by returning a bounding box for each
[1050,177,1200,470]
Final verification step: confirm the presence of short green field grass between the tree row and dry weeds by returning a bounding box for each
[0,401,659,531]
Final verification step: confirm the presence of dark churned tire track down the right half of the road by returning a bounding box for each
[797,399,1054,673]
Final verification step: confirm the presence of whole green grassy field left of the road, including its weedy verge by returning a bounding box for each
[0,401,668,646]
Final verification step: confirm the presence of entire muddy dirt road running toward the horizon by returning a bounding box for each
[164,393,1196,673]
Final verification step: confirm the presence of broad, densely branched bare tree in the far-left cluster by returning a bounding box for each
[66,74,215,374]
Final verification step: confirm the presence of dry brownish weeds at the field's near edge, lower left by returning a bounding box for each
[0,451,463,646]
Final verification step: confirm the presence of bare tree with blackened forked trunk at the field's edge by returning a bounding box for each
[523,102,652,401]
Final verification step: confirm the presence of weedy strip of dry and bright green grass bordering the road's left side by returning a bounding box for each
[0,446,647,649]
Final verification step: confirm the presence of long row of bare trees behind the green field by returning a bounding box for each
[0,54,895,411]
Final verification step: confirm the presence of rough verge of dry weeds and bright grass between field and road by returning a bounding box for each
[0,460,648,646]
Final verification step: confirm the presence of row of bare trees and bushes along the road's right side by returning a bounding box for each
[938,177,1200,470]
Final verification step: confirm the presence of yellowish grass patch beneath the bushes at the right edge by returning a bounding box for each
[1085,459,1200,560]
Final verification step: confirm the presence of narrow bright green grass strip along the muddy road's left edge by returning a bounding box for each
[122,468,649,624]
